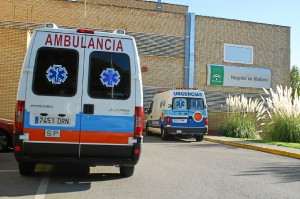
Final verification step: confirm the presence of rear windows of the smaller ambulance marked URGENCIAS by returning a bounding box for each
[172,97,204,110]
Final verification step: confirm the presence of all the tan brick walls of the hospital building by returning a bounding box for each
[0,0,290,130]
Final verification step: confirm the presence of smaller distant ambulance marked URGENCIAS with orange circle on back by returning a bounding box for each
[146,89,208,141]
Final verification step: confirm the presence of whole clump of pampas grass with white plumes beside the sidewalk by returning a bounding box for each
[224,86,300,143]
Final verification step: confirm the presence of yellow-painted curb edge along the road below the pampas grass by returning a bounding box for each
[204,137,300,159]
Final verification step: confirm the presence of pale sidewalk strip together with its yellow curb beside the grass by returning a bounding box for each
[204,135,300,159]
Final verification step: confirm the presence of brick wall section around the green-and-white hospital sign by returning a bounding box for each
[195,16,290,93]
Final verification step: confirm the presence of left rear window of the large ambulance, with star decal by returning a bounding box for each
[32,47,79,97]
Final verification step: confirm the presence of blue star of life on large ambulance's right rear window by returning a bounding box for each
[100,68,121,87]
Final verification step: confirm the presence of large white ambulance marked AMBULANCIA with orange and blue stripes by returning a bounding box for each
[14,24,144,176]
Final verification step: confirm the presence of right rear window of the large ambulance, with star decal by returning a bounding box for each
[88,51,131,100]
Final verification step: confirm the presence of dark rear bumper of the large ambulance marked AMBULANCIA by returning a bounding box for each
[14,134,142,166]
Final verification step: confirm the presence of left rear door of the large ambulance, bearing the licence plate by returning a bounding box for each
[22,29,84,158]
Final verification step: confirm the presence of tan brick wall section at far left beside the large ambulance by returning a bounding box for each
[0,28,27,119]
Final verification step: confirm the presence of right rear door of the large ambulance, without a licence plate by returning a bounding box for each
[80,35,137,159]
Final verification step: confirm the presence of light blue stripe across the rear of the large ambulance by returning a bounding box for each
[24,111,134,132]
